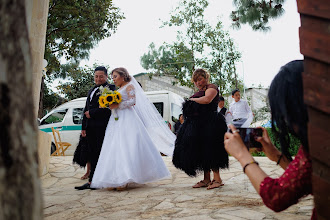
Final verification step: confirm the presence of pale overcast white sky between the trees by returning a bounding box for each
[81,0,303,87]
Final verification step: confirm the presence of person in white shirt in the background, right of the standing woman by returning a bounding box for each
[228,89,253,127]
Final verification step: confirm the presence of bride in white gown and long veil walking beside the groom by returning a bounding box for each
[91,68,176,188]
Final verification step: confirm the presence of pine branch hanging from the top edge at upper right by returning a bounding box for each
[230,0,285,31]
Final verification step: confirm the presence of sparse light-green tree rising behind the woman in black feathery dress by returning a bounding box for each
[141,0,241,94]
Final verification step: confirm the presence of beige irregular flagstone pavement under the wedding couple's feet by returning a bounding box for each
[41,156,313,220]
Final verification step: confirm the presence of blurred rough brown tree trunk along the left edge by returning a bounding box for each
[0,0,43,220]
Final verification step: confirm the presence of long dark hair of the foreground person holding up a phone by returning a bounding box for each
[268,60,308,159]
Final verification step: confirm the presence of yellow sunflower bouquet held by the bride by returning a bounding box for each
[99,86,122,121]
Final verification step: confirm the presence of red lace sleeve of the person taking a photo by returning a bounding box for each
[260,147,312,212]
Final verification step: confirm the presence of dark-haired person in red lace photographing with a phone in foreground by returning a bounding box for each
[225,60,316,219]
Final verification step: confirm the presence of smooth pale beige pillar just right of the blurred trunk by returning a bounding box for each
[26,0,49,119]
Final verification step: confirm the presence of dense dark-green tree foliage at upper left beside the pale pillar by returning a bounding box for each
[45,0,124,80]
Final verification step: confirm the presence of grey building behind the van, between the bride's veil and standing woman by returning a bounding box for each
[134,73,194,97]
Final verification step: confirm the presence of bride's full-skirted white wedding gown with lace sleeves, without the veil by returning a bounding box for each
[91,82,171,188]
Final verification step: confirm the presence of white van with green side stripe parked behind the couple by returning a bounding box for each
[39,91,184,155]
